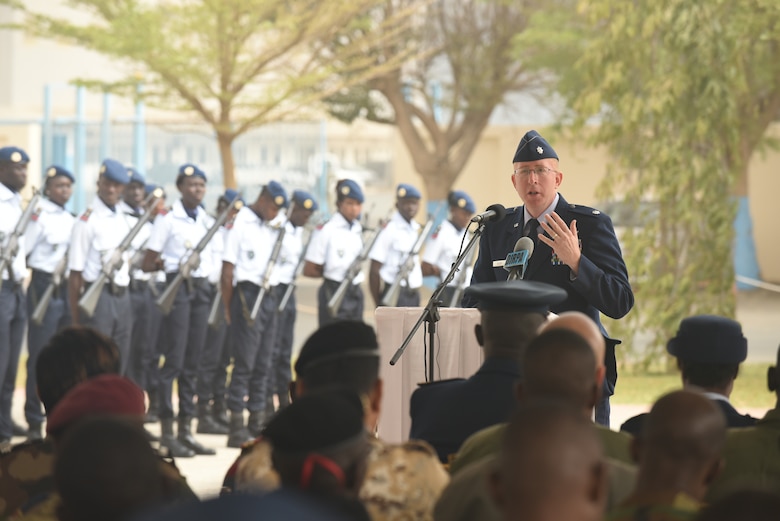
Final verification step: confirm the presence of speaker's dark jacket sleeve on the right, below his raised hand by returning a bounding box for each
[571,210,634,319]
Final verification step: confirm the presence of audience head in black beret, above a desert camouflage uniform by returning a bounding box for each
[291,320,382,429]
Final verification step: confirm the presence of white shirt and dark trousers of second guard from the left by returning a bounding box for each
[24,195,76,427]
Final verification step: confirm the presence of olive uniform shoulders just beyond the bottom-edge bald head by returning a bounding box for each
[450,423,634,475]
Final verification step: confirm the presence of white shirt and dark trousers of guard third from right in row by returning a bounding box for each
[306,212,365,327]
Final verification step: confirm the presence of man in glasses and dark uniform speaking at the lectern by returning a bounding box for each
[463,130,634,426]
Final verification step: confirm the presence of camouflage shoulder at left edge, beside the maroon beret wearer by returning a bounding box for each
[0,440,54,519]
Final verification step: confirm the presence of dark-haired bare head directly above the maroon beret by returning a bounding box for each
[35,327,119,414]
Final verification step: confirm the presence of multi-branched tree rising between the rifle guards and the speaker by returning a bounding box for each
[328,0,567,199]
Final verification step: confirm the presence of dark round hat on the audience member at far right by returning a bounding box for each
[666,315,747,365]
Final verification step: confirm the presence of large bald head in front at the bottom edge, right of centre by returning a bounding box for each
[490,402,607,521]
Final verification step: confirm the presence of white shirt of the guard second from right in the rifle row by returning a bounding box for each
[368,211,422,290]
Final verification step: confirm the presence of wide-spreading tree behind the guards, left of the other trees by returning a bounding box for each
[0,0,414,187]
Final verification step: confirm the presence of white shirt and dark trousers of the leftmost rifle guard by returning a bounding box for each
[0,183,27,442]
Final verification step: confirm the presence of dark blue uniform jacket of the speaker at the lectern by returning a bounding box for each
[463,195,634,386]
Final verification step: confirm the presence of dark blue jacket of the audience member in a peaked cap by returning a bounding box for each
[409,357,520,463]
